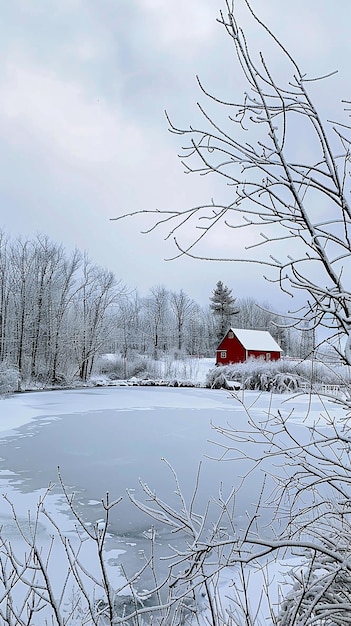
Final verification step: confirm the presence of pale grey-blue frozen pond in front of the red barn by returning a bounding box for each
[0,387,258,534]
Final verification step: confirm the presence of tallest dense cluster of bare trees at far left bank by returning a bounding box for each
[0,233,122,383]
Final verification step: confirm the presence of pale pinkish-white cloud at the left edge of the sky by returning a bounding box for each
[0,62,142,163]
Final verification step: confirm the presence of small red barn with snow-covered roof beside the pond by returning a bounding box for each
[216,328,282,365]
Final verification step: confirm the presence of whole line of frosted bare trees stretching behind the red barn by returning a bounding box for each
[0,233,312,384]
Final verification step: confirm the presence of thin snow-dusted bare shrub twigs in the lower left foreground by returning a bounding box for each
[0,476,173,626]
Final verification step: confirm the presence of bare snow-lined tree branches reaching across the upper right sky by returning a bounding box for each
[116,0,351,363]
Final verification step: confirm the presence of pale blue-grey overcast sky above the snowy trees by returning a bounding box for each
[0,0,351,309]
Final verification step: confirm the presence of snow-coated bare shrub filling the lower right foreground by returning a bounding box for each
[126,396,351,626]
